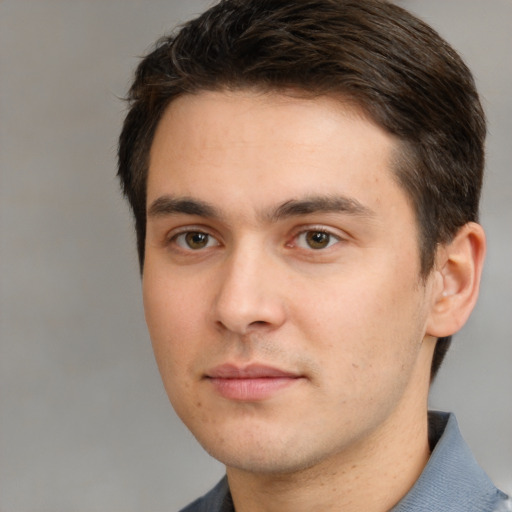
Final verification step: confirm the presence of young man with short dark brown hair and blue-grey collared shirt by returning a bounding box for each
[119,0,510,512]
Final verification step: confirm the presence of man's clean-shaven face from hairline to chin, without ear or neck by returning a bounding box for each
[143,91,432,473]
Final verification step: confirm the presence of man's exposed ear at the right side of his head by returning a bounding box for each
[427,222,486,338]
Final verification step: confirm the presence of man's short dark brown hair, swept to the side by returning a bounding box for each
[119,0,485,396]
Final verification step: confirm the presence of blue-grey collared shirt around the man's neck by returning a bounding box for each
[181,412,512,512]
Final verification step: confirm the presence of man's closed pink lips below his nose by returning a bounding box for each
[206,364,302,402]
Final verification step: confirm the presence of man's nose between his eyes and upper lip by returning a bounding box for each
[210,241,286,335]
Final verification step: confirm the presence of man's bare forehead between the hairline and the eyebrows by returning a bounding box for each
[147,90,408,220]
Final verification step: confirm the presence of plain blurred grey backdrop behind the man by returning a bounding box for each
[0,0,512,512]
